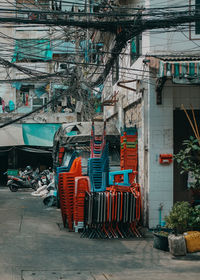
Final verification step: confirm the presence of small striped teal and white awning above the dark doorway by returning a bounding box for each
[146,56,200,78]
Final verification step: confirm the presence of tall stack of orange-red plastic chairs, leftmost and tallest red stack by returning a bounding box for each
[58,157,82,230]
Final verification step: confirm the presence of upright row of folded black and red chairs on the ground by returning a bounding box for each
[81,186,141,238]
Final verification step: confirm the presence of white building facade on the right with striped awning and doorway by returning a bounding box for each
[103,0,200,228]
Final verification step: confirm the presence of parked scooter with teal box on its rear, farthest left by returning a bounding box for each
[7,166,38,192]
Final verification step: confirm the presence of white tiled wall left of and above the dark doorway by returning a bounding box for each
[148,80,200,227]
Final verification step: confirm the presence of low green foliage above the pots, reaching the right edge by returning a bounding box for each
[165,201,200,233]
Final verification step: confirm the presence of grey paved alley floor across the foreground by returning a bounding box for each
[0,187,200,280]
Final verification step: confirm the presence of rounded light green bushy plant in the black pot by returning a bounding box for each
[165,201,193,234]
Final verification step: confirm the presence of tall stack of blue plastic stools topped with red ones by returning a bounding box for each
[88,123,109,192]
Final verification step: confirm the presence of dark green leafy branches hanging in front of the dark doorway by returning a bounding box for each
[174,136,200,189]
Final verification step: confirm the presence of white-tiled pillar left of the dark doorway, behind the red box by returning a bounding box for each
[148,79,173,228]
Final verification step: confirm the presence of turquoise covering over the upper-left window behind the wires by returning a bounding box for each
[12,39,52,62]
